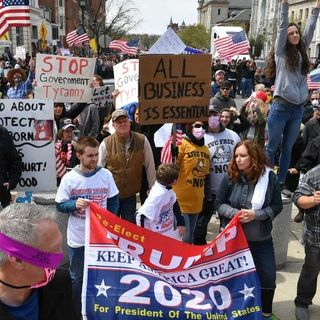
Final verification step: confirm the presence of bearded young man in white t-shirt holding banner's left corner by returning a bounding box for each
[56,137,119,319]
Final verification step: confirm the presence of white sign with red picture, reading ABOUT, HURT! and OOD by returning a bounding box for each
[0,99,56,192]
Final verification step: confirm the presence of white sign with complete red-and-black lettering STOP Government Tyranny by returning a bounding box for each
[35,53,96,102]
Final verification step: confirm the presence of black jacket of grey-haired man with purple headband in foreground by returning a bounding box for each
[0,270,76,320]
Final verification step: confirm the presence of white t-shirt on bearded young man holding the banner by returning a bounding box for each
[56,168,119,248]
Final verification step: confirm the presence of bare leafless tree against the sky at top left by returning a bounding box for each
[85,0,141,52]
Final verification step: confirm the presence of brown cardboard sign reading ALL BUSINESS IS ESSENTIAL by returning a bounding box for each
[139,54,211,124]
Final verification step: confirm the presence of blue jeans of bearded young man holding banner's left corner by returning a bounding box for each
[69,247,84,319]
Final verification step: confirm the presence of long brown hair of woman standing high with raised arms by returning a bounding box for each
[264,22,310,79]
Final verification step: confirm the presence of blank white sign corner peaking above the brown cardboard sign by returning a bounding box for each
[148,28,186,54]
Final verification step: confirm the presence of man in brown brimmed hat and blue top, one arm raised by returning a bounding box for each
[7,60,36,99]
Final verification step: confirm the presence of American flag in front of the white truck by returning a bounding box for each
[214,31,250,59]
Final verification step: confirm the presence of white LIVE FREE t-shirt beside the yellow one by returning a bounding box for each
[204,129,240,194]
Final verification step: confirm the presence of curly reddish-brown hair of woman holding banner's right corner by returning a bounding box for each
[227,140,270,183]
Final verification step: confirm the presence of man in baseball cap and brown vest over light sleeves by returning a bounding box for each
[98,109,155,223]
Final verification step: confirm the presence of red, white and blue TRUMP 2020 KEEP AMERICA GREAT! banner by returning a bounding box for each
[82,203,262,320]
